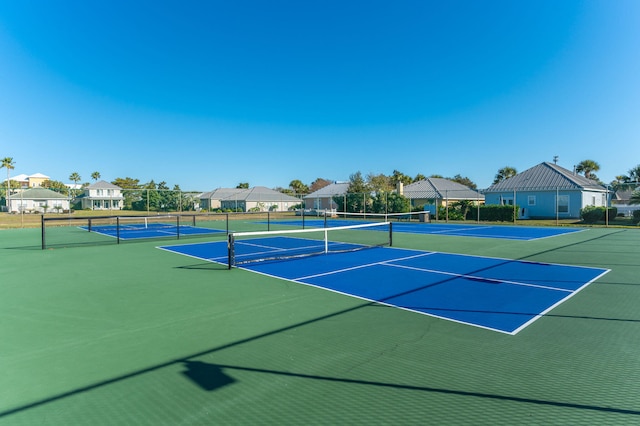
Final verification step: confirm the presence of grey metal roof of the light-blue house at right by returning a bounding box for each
[485,162,606,192]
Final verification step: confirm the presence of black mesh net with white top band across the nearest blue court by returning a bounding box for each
[228,222,393,269]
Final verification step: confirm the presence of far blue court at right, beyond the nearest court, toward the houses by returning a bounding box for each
[262,219,584,241]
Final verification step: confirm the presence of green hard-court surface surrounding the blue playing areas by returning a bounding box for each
[0,228,640,426]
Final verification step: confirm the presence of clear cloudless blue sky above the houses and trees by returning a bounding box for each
[0,0,640,190]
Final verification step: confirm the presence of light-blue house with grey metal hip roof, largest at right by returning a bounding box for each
[484,162,610,219]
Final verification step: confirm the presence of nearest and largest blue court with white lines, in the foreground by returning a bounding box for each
[159,237,608,334]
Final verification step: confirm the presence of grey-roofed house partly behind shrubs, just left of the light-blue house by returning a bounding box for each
[398,178,484,214]
